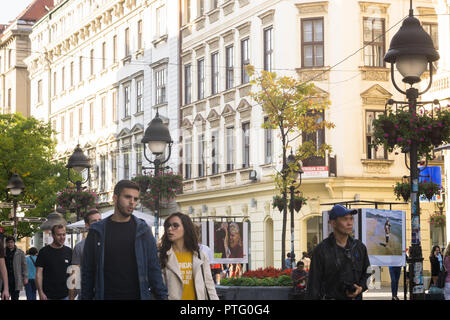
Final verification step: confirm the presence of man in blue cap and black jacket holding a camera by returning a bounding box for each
[307,205,370,300]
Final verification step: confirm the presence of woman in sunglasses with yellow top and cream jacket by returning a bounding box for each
[159,212,219,300]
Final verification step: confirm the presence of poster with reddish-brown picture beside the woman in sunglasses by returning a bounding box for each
[209,221,248,264]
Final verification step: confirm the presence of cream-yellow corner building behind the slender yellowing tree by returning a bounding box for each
[177,0,446,279]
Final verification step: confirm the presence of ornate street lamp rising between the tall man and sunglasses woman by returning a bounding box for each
[141,111,173,240]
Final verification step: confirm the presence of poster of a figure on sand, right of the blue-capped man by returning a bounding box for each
[360,208,406,267]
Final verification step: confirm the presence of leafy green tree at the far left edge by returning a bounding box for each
[0,113,67,239]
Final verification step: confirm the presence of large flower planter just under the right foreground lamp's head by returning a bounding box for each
[372,107,450,159]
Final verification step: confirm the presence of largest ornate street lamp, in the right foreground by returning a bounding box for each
[384,0,439,299]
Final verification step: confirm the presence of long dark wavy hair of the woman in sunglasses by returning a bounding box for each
[159,212,199,268]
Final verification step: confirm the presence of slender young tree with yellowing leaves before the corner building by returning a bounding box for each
[246,66,334,269]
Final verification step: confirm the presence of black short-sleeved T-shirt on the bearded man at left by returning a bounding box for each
[36,245,72,299]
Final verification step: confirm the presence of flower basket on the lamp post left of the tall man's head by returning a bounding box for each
[56,187,98,211]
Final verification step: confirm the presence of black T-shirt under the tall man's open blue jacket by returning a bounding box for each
[104,218,140,300]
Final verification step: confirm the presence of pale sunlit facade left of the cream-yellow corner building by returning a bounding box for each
[27,0,179,203]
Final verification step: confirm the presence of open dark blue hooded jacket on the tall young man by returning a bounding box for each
[81,216,168,300]
